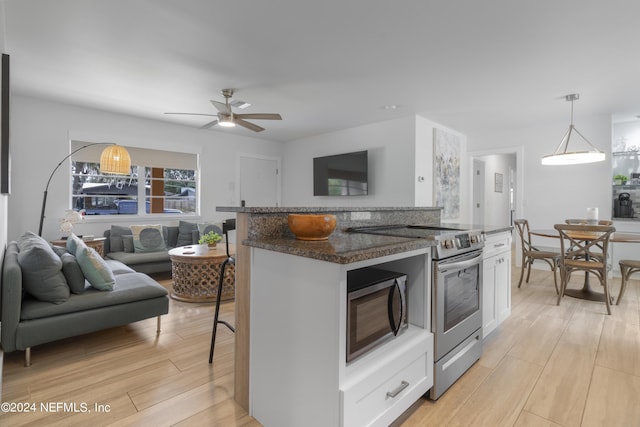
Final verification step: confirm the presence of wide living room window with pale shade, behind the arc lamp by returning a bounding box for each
[71,141,198,215]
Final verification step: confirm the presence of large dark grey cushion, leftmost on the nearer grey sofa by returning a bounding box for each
[18,232,70,304]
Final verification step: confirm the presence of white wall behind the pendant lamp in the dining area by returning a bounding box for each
[468,115,612,232]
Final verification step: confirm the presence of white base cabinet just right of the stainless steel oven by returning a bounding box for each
[482,232,511,338]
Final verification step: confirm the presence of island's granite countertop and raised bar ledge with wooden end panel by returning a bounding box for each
[216,206,442,418]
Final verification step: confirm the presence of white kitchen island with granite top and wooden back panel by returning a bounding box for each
[214,207,512,426]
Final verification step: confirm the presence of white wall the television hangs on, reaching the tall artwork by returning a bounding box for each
[282,116,469,221]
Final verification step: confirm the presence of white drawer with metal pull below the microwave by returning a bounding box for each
[343,354,433,426]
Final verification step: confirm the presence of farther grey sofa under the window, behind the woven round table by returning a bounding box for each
[103,221,222,274]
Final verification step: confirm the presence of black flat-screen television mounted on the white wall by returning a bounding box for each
[313,151,369,196]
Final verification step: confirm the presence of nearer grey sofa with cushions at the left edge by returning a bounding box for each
[0,233,169,366]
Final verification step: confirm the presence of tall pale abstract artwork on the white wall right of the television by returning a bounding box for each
[433,129,460,219]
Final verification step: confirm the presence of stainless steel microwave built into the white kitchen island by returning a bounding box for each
[347,267,409,362]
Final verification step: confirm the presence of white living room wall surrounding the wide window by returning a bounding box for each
[8,96,282,240]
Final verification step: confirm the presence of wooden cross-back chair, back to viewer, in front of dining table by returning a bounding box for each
[554,224,616,314]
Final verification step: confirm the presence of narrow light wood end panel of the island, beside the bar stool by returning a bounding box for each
[231,213,251,412]
